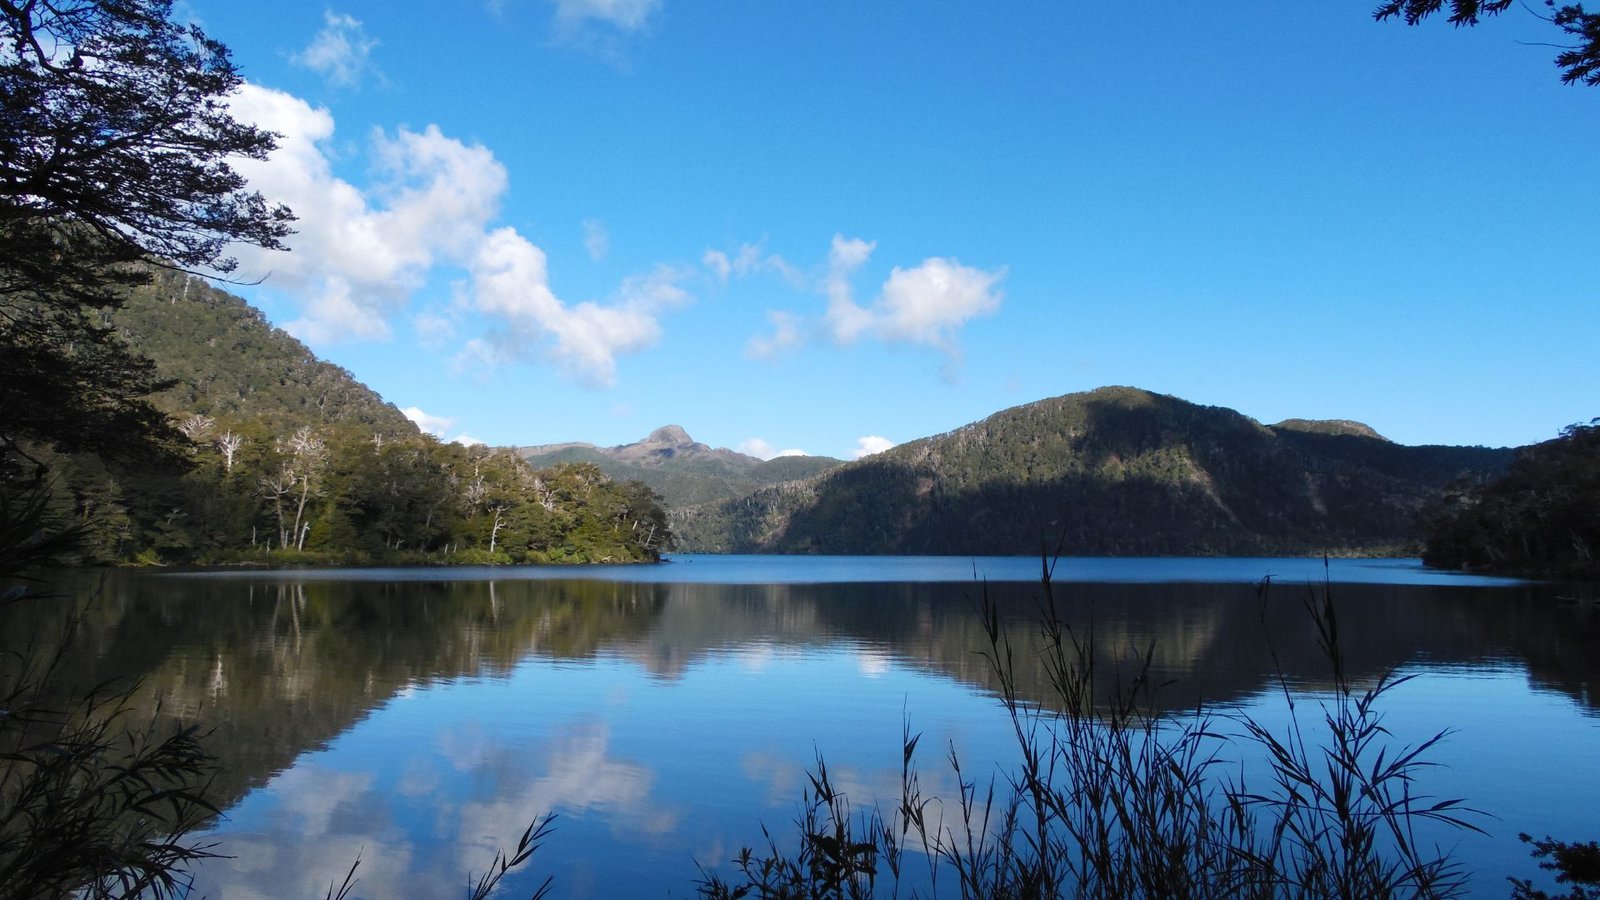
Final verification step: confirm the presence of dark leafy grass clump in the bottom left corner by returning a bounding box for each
[0,488,216,900]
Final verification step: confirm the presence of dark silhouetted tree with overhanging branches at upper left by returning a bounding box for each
[0,0,293,470]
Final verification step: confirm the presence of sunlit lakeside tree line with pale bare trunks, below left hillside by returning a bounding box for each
[37,415,670,564]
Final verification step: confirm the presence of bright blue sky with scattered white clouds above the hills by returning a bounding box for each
[190,0,1600,456]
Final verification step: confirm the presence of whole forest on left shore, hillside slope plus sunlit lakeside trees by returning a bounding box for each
[11,272,670,564]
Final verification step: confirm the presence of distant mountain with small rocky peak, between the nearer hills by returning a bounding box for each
[517,424,843,509]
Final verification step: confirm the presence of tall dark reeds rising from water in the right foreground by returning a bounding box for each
[699,564,1477,900]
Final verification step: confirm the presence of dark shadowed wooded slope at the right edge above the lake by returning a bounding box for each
[1422,420,1600,578]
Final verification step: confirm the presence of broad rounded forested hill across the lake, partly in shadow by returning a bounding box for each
[672,388,1512,556]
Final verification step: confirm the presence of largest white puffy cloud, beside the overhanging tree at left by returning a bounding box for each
[230,85,690,386]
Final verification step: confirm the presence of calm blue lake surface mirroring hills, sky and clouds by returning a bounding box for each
[0,556,1600,898]
